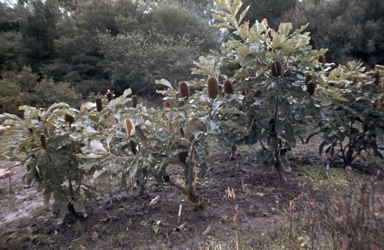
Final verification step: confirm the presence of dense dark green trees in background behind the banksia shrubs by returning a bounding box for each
[0,0,384,112]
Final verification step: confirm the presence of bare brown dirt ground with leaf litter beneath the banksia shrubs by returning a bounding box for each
[0,140,380,250]
